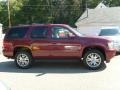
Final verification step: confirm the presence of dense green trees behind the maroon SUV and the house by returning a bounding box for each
[0,0,120,27]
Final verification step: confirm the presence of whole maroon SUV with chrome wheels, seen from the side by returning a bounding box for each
[3,24,116,69]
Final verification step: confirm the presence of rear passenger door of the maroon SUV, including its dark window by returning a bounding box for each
[30,26,51,57]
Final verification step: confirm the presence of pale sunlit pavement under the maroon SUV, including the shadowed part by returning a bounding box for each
[0,55,120,90]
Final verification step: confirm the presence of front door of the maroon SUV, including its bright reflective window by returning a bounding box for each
[51,26,81,57]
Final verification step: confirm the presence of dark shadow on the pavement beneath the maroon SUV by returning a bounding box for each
[0,60,106,76]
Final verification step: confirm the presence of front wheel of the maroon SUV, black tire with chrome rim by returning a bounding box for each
[83,49,105,70]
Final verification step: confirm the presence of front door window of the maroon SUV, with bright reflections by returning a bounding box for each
[52,27,74,39]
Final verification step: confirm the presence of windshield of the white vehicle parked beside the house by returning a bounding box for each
[99,29,120,36]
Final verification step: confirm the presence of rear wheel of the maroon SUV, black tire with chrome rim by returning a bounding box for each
[15,51,33,69]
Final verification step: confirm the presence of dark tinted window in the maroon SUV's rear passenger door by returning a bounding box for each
[31,27,48,39]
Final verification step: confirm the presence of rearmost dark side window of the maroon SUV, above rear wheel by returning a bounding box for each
[6,27,28,39]
